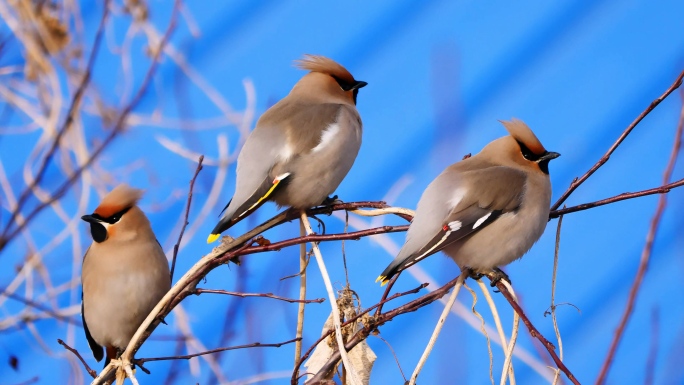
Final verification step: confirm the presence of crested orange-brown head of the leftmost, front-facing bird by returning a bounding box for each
[81,184,149,243]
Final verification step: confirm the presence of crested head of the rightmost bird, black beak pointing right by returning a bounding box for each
[482,118,560,175]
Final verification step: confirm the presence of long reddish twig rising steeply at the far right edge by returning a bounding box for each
[596,93,684,385]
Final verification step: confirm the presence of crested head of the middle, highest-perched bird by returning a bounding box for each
[293,55,368,105]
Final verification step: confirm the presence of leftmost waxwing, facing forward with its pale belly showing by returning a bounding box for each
[81,184,171,366]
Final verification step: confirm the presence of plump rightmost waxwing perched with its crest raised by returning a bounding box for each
[376,119,560,285]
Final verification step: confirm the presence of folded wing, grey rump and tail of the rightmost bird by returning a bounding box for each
[377,166,526,283]
